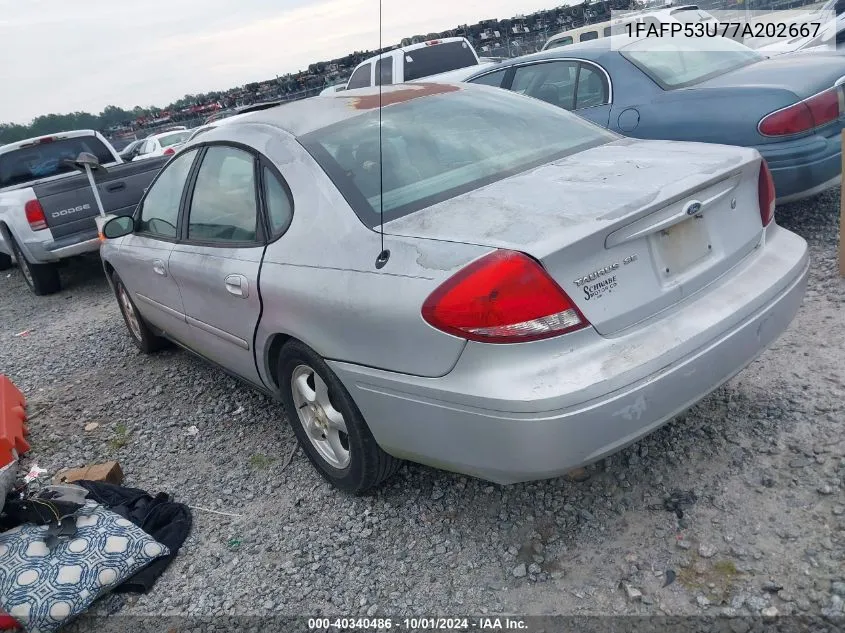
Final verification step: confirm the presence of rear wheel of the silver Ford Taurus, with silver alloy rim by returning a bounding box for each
[278,341,402,494]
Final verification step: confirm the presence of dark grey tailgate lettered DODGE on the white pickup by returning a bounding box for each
[33,156,169,238]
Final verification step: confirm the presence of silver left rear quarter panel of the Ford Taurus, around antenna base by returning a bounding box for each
[237,125,489,384]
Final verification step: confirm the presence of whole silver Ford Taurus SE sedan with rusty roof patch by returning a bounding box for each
[102,84,808,492]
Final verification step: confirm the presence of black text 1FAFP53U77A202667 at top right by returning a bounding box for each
[625,21,822,39]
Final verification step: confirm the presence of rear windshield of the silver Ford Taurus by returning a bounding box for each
[300,87,617,227]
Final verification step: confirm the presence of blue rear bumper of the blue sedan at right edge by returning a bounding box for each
[756,127,842,203]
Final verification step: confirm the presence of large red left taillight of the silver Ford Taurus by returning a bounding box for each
[422,250,589,343]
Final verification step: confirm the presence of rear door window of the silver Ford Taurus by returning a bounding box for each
[188,146,258,242]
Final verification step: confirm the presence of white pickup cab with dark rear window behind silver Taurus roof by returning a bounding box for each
[346,37,480,90]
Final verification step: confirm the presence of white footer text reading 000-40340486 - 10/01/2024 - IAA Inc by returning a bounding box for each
[308,617,527,631]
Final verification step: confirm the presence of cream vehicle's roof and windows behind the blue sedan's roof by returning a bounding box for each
[543,4,718,51]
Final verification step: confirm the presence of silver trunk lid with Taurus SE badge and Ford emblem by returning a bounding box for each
[384,139,763,335]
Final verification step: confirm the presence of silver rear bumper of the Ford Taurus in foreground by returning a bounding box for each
[330,225,808,483]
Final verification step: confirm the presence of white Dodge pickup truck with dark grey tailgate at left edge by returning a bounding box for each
[0,130,169,295]
